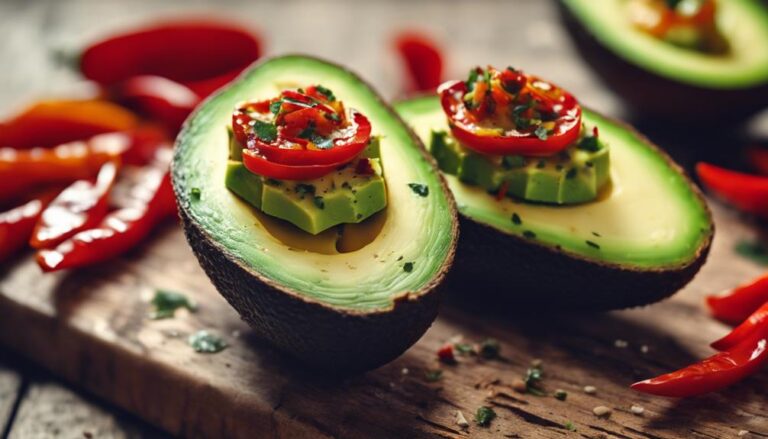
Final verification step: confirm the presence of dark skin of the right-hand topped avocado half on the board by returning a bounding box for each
[446,115,714,314]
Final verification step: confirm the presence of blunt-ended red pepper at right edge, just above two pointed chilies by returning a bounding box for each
[707,274,768,325]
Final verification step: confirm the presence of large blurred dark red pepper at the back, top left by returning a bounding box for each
[80,20,261,97]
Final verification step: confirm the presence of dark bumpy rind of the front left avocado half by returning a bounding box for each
[172,55,458,375]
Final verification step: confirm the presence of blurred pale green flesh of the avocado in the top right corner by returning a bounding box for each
[561,0,768,89]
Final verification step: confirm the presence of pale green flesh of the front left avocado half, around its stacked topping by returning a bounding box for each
[174,56,455,312]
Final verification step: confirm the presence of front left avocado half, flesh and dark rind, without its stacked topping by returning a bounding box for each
[173,55,458,373]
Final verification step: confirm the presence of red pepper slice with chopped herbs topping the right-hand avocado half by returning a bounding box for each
[438,67,581,156]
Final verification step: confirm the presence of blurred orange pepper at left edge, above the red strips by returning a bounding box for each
[0,100,139,149]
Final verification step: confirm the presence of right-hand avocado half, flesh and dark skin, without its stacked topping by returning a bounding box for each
[395,96,714,310]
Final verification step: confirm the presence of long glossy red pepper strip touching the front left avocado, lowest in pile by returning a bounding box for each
[37,150,176,272]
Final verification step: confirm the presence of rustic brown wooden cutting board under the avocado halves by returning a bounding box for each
[0,204,768,439]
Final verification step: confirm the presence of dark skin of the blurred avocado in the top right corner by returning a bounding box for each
[557,0,768,124]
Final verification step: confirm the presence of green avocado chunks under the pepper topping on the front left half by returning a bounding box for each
[225,140,387,235]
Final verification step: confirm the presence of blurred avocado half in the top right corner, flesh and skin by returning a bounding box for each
[558,0,768,122]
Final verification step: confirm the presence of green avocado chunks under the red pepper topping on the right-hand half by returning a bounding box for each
[428,131,610,204]
